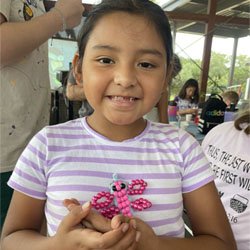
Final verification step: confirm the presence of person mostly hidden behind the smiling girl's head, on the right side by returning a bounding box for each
[144,54,182,124]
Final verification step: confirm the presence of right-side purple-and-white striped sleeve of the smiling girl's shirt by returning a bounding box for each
[179,130,215,193]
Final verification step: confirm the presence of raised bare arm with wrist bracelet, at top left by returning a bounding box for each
[0,0,84,65]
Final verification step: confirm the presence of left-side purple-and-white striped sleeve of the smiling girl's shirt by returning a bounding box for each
[8,129,47,200]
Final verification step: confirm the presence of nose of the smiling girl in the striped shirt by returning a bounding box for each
[114,65,137,88]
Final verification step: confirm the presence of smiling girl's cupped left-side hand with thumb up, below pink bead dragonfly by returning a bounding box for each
[53,202,139,250]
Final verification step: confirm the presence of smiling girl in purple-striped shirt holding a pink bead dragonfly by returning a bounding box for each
[1,0,236,250]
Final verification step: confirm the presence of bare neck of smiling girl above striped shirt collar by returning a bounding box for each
[87,115,147,142]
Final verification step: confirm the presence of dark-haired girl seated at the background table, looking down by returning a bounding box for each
[174,78,199,116]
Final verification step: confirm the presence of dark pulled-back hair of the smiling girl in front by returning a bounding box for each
[78,0,173,66]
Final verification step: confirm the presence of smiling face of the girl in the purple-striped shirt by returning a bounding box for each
[75,12,170,131]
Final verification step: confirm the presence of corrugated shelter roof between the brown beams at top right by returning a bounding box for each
[162,0,250,37]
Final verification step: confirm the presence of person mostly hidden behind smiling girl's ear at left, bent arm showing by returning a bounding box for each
[66,69,94,117]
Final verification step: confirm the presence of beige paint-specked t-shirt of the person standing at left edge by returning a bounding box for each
[0,0,50,173]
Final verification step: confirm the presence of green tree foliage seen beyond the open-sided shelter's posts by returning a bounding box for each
[170,52,250,99]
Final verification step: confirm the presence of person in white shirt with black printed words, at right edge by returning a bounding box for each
[202,108,250,250]
